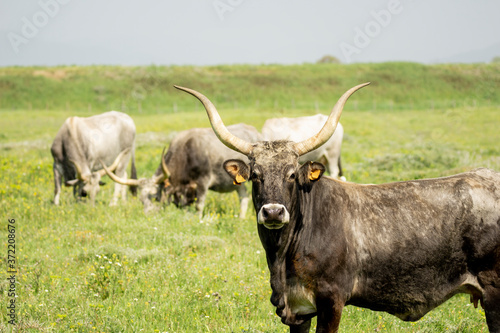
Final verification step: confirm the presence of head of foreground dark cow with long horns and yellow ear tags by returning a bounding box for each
[175,83,369,229]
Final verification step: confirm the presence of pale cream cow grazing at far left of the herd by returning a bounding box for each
[50,111,136,205]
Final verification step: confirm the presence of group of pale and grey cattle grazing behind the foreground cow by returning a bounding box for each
[51,111,345,218]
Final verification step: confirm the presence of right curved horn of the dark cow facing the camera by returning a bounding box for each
[294,82,370,156]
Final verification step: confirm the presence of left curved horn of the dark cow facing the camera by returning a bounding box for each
[174,85,252,155]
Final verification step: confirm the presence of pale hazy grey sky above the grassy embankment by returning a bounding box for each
[0,0,500,66]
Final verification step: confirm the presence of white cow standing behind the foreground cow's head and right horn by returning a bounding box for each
[262,114,345,180]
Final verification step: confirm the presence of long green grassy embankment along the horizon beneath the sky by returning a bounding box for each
[0,62,500,113]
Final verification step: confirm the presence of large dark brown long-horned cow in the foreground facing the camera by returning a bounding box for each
[177,84,500,333]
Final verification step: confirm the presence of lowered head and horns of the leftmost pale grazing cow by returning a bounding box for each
[65,148,130,205]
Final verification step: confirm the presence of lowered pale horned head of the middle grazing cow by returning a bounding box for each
[101,148,170,213]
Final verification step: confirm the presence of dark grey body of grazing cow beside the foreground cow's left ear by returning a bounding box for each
[155,124,261,218]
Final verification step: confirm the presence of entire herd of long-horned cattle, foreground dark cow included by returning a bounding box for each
[48,84,500,333]
